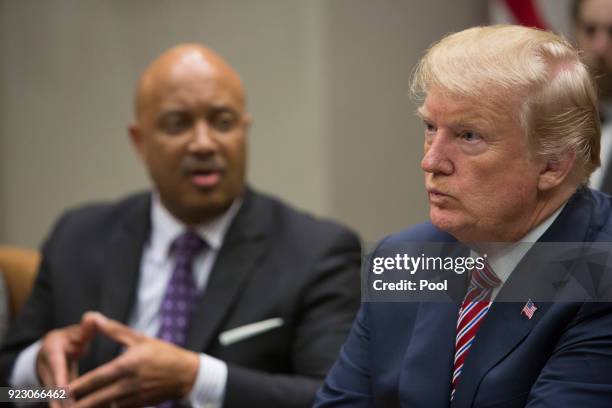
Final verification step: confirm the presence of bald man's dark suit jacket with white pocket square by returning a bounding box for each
[0,190,361,407]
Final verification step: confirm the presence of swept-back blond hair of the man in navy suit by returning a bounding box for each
[411,25,600,183]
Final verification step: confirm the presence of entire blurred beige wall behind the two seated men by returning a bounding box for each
[0,0,571,247]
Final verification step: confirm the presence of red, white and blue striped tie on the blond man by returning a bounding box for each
[451,264,501,401]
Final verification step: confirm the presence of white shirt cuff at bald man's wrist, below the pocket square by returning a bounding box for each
[188,354,227,408]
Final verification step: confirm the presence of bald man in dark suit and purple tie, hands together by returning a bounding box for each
[0,44,360,407]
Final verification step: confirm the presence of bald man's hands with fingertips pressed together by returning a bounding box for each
[36,312,200,408]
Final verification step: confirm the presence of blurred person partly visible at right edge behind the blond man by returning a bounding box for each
[572,0,612,194]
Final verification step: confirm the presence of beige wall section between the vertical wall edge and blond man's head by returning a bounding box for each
[326,0,487,240]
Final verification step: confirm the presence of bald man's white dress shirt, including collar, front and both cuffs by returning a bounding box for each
[11,194,242,408]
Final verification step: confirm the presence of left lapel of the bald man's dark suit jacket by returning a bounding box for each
[97,194,151,362]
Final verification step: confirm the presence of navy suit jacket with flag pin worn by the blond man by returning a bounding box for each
[315,190,612,408]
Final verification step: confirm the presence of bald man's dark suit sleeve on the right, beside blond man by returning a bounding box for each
[224,226,361,407]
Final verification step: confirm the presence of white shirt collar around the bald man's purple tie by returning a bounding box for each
[149,193,243,262]
